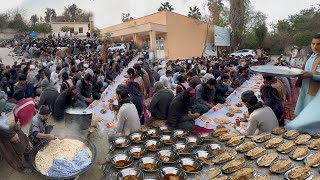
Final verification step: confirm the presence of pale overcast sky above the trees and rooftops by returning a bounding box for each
[0,0,320,28]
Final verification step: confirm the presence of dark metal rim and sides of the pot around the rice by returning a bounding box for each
[29,136,97,179]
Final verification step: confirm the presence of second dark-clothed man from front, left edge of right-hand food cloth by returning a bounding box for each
[193,79,216,114]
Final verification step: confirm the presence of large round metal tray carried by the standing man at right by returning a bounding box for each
[250,65,303,77]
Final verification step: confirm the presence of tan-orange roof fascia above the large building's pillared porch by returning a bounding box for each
[101,11,167,34]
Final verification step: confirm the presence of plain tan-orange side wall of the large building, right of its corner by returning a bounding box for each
[165,12,214,59]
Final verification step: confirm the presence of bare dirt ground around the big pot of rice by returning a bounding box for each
[0,115,109,180]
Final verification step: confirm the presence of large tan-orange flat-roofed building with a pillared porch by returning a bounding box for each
[101,11,214,59]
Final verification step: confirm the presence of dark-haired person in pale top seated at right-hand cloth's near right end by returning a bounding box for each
[234,91,279,135]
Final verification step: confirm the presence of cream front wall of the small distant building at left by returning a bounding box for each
[51,22,90,36]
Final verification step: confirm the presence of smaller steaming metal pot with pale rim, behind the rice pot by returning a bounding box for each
[65,108,92,130]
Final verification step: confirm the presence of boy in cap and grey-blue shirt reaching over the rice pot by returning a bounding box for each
[29,106,56,147]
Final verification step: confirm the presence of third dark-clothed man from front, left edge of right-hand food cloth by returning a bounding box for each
[214,74,229,104]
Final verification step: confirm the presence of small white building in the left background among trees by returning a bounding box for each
[50,22,90,37]
